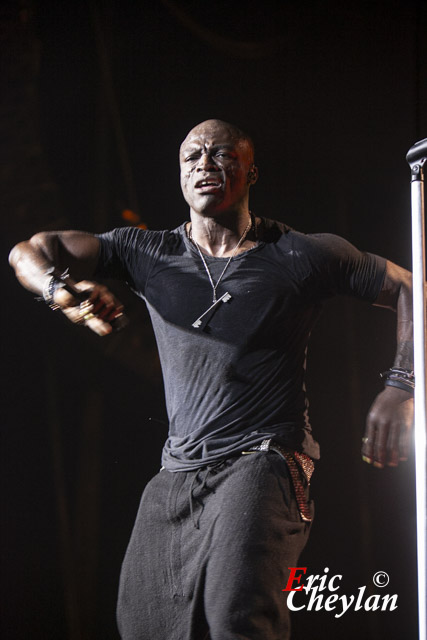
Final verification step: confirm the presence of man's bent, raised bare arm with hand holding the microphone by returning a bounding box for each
[9,231,123,336]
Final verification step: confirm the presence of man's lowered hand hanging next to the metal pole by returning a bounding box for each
[362,387,414,469]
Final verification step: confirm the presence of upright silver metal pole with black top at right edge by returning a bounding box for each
[406,138,427,640]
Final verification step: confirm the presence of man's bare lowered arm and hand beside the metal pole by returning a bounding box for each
[362,261,414,468]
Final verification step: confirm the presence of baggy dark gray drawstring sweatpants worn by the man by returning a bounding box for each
[118,451,310,640]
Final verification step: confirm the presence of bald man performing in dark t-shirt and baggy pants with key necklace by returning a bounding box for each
[10,120,413,640]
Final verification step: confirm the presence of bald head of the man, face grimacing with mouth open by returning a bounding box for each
[179,120,254,216]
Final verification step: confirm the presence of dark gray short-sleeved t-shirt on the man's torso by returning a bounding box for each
[97,219,385,471]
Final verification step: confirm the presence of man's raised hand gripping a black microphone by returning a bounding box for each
[54,280,123,336]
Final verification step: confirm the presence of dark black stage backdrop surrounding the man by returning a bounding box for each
[0,0,427,640]
